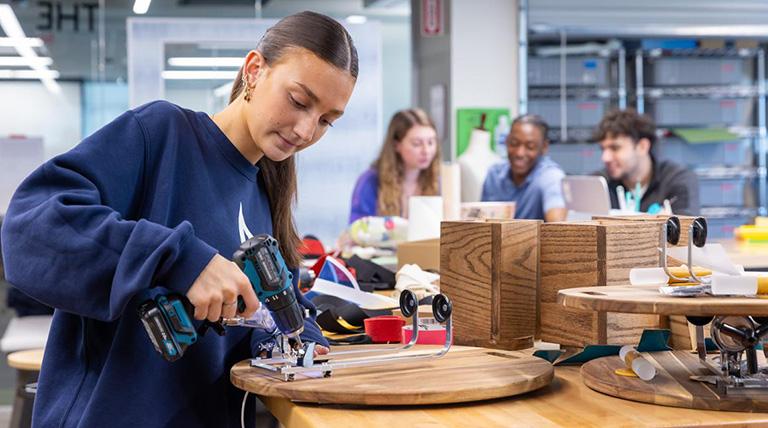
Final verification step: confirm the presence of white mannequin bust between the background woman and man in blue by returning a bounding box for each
[458,129,504,202]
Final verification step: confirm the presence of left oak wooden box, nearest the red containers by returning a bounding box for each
[440,220,541,350]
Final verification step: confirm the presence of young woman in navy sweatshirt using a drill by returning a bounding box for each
[2,12,358,427]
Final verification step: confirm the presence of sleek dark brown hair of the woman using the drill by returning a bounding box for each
[229,11,358,267]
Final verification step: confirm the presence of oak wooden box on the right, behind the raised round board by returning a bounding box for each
[538,219,666,346]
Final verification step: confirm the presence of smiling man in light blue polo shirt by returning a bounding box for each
[482,114,568,221]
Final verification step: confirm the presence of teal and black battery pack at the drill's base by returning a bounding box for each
[138,294,198,361]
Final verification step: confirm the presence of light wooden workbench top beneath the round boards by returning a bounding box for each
[255,367,768,428]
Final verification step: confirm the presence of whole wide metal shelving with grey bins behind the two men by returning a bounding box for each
[520,19,768,238]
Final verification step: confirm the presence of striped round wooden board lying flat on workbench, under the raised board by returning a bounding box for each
[581,351,768,412]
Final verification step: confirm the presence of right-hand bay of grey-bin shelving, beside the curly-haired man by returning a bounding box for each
[634,49,767,239]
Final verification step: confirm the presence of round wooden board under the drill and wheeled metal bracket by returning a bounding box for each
[230,346,554,406]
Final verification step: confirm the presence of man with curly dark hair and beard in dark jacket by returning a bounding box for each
[594,109,699,215]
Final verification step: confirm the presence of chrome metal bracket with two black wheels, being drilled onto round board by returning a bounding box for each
[251,291,453,381]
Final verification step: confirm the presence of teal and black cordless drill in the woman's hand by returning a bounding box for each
[138,235,304,361]
